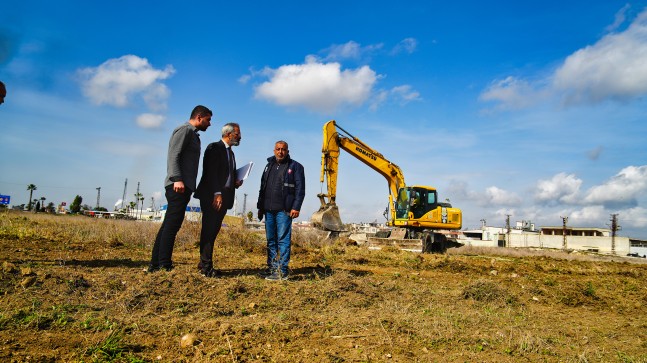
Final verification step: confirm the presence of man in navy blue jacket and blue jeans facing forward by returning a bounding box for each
[256,141,306,280]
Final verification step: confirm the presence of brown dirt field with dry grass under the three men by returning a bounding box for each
[0,212,647,362]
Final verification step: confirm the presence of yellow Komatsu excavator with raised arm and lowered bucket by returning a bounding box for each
[311,120,462,252]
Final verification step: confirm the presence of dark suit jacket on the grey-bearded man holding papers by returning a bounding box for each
[193,140,236,209]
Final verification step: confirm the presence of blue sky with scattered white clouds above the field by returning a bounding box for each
[0,0,647,238]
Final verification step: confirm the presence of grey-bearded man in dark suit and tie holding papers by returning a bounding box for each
[194,122,243,277]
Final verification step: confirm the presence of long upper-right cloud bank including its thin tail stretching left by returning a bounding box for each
[479,7,647,110]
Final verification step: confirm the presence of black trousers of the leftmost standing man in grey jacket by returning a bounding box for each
[151,185,191,267]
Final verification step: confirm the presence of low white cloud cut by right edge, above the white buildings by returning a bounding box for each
[584,165,647,205]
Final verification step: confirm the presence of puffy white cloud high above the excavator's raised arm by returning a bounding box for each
[255,56,378,112]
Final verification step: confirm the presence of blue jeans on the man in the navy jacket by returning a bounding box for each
[265,211,292,275]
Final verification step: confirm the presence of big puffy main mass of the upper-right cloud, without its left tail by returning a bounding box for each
[554,11,647,104]
